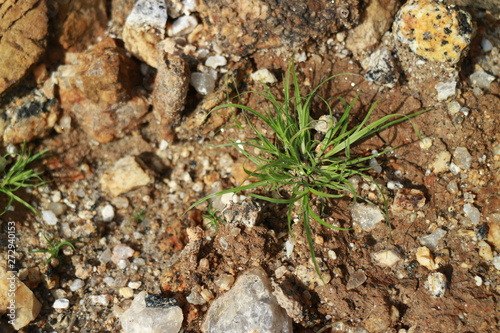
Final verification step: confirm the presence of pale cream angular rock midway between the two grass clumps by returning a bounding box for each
[100,155,152,196]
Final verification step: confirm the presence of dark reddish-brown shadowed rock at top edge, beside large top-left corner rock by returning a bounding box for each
[52,0,108,52]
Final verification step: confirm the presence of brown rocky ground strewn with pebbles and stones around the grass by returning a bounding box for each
[0,0,500,333]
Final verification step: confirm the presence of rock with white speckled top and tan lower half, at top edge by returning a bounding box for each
[123,0,168,68]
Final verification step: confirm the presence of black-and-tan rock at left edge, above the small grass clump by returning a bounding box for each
[0,89,59,144]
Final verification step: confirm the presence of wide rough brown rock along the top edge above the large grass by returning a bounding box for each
[200,0,360,56]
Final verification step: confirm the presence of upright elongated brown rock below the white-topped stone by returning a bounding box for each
[153,49,190,141]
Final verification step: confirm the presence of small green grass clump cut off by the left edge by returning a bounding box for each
[0,144,47,215]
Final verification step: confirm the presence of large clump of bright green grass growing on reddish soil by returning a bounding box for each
[190,63,427,274]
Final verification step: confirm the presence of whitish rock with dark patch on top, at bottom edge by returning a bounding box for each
[119,291,184,333]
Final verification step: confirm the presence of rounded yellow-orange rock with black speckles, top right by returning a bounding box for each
[393,0,474,64]
